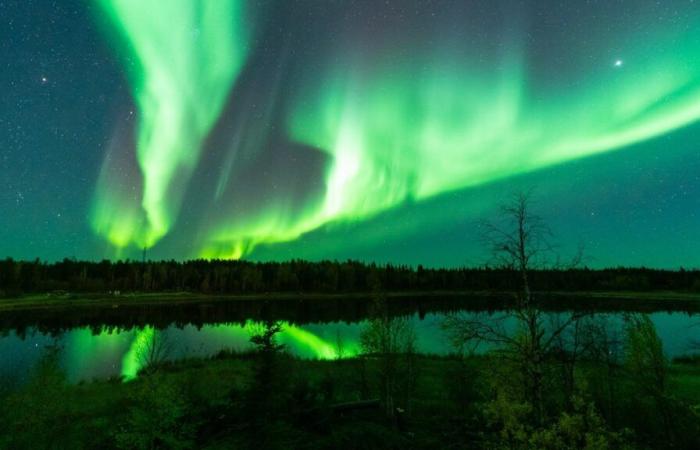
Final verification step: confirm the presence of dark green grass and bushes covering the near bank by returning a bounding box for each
[0,321,700,449]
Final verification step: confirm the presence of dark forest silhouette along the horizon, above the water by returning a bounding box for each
[0,258,700,297]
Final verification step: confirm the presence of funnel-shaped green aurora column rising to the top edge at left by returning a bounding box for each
[92,0,248,247]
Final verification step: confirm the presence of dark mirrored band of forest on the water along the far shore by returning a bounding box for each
[0,291,700,333]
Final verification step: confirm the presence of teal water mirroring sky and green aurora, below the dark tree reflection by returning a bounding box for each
[0,312,700,382]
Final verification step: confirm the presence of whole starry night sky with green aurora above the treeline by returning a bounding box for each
[0,0,700,268]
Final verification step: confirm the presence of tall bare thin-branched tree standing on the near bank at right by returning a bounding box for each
[444,193,583,423]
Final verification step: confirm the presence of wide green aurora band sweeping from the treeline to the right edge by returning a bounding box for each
[199,14,700,258]
